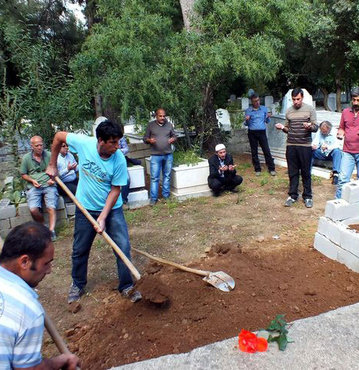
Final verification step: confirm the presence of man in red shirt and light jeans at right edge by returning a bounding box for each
[335,87,359,199]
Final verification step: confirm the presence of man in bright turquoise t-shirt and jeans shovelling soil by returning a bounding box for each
[46,121,142,303]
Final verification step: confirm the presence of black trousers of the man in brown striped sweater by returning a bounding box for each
[285,145,312,199]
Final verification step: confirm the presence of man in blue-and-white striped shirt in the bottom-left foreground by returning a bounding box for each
[0,222,79,370]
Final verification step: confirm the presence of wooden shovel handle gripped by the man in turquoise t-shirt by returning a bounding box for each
[55,176,141,280]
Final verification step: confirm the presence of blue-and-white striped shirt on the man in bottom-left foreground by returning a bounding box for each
[0,266,44,370]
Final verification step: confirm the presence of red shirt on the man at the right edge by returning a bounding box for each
[339,108,359,154]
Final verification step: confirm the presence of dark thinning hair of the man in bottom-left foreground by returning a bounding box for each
[0,221,51,262]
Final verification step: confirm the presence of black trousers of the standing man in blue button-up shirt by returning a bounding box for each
[248,130,275,172]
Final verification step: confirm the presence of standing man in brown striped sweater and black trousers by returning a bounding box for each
[275,88,318,208]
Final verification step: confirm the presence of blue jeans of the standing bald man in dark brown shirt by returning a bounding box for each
[150,153,173,202]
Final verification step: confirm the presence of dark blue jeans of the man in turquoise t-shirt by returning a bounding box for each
[72,207,133,292]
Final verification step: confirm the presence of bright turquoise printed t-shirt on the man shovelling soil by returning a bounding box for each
[66,134,127,211]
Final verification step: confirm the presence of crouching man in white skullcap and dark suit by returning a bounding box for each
[208,144,243,197]
